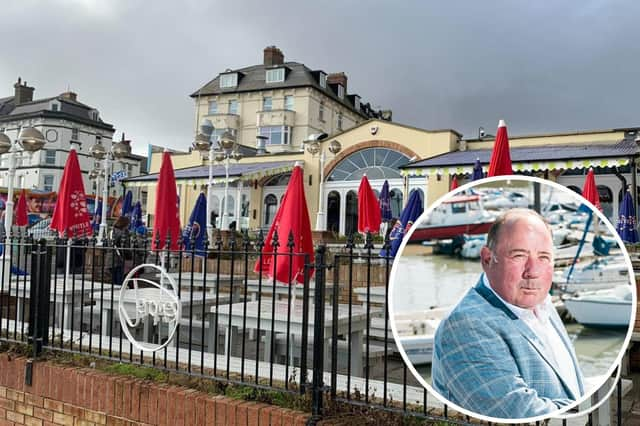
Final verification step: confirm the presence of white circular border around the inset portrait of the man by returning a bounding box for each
[388,175,637,423]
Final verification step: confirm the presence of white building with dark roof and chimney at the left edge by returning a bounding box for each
[0,78,146,205]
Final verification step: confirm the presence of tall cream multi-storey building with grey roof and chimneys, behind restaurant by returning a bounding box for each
[191,46,391,153]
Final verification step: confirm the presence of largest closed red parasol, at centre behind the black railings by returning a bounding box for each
[253,165,314,284]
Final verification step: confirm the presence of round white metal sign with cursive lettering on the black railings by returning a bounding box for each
[118,264,182,352]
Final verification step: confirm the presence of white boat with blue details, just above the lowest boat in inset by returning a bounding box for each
[553,257,629,293]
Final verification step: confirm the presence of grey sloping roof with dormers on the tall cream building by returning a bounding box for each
[190,62,374,118]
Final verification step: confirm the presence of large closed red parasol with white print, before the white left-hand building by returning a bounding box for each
[50,149,91,238]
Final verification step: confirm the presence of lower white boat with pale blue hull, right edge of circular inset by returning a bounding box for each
[564,284,633,328]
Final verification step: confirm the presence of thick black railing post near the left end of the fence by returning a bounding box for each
[28,239,51,357]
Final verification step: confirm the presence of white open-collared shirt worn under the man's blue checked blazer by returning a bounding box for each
[482,274,582,395]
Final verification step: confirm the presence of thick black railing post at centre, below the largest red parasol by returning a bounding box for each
[310,245,327,423]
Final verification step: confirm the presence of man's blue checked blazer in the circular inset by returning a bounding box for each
[431,279,584,419]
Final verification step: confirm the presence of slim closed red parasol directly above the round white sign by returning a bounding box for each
[151,151,180,250]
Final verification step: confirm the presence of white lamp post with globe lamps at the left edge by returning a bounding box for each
[0,127,45,233]
